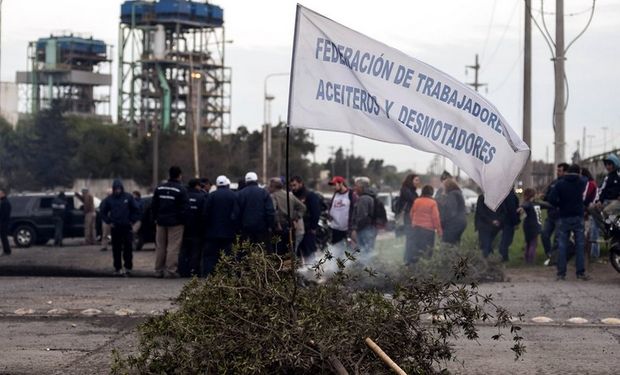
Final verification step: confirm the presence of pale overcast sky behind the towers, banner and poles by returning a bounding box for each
[2,0,620,172]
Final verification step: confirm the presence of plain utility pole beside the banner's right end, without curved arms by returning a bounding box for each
[521,0,534,187]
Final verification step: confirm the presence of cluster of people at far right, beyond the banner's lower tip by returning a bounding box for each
[475,154,620,280]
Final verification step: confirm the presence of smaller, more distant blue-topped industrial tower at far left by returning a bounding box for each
[16,33,112,118]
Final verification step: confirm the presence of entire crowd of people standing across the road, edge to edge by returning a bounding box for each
[0,155,620,280]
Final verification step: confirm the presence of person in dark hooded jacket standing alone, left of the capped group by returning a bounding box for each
[100,180,140,276]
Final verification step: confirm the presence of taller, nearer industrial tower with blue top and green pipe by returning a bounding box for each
[117,0,231,138]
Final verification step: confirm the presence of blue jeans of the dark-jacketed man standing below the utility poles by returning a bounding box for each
[557,216,585,276]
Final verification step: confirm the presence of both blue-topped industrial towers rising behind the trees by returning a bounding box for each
[11,0,231,138]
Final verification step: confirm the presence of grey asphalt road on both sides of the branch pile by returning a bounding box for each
[0,243,620,374]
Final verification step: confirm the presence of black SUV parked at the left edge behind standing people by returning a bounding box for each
[9,193,100,247]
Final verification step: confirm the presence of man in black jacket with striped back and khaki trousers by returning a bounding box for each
[152,166,189,278]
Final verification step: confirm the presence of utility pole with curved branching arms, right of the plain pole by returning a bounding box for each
[553,0,566,165]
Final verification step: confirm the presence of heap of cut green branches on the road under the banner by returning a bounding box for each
[112,243,525,374]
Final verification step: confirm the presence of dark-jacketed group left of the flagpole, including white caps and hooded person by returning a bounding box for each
[100,166,330,278]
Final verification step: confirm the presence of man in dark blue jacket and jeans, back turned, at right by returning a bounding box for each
[549,164,590,280]
